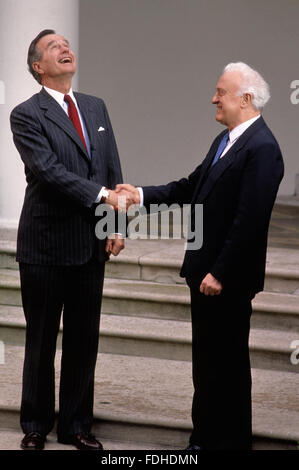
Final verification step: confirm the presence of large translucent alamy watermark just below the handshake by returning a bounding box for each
[95,196,203,250]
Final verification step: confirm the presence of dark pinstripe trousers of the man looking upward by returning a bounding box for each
[20,258,105,438]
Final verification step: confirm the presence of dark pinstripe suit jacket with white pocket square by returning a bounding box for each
[10,89,122,265]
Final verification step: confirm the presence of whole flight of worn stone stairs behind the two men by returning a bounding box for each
[0,233,299,449]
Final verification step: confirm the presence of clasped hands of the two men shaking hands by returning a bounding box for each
[102,184,140,212]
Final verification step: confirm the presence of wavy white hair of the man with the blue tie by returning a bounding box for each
[223,62,270,111]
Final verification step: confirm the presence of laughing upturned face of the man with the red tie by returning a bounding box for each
[32,34,76,85]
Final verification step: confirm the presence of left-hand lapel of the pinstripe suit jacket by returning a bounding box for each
[39,88,90,162]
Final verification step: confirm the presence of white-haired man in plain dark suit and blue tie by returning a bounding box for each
[117,62,284,450]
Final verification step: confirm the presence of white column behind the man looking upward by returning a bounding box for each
[0,0,79,227]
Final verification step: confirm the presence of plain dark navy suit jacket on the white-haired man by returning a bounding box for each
[143,117,284,295]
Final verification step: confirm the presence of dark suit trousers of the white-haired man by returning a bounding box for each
[190,287,252,450]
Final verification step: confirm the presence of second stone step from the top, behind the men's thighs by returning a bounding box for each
[0,269,299,333]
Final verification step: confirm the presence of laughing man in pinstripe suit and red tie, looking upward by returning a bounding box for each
[11,30,124,450]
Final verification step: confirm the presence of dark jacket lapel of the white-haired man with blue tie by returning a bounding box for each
[196,116,266,202]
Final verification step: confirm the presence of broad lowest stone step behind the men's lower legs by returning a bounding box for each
[0,345,299,449]
